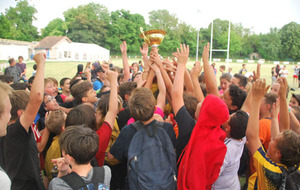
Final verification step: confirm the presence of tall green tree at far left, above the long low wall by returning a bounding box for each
[6,0,38,41]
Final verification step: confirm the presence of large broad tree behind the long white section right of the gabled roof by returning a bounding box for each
[64,3,109,47]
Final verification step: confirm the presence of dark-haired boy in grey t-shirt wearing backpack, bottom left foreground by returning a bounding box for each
[49,125,111,190]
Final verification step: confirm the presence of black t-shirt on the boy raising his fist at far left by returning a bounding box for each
[1,119,44,190]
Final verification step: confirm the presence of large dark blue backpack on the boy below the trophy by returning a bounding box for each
[127,121,177,190]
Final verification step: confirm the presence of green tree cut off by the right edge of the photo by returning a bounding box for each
[279,22,300,60]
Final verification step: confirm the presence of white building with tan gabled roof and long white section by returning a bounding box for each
[34,36,109,61]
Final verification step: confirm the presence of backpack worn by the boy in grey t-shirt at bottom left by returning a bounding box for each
[60,167,108,190]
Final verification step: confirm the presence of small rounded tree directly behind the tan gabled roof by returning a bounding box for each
[42,18,68,38]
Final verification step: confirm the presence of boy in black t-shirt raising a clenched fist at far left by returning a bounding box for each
[1,53,46,190]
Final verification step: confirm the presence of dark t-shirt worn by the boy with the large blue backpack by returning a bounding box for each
[109,120,176,161]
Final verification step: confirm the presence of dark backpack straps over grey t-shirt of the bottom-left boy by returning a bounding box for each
[61,167,105,190]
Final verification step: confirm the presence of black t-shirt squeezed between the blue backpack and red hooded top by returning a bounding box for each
[175,106,196,160]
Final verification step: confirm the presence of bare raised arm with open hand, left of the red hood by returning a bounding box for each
[171,44,189,116]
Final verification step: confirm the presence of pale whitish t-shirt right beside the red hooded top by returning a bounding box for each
[212,137,246,190]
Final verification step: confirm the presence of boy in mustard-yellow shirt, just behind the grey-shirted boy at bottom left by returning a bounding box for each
[45,110,66,181]
